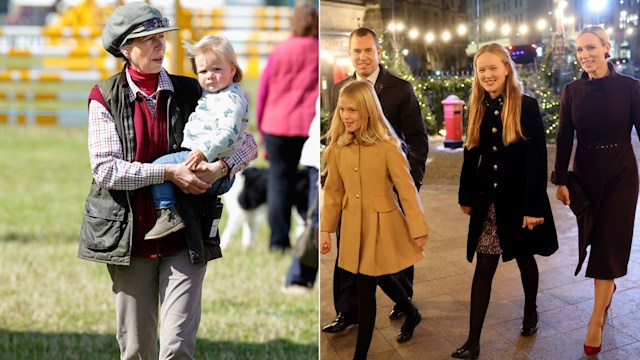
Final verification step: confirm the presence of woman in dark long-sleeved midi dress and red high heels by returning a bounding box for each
[551,26,640,355]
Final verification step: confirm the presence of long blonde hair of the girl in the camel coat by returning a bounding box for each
[321,80,401,174]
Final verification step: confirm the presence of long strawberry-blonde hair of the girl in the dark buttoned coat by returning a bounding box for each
[465,43,524,149]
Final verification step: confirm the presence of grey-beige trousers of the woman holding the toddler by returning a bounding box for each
[107,250,207,360]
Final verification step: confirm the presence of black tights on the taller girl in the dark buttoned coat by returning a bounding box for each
[463,253,538,350]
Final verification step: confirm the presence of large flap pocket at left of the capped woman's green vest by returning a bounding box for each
[81,197,127,251]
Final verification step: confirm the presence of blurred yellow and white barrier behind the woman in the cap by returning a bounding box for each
[0,0,293,125]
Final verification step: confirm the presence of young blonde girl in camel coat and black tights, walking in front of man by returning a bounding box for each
[320,81,428,359]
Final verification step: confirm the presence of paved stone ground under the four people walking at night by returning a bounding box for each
[320,135,640,360]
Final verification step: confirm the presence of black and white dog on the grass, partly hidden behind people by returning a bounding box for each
[220,167,309,249]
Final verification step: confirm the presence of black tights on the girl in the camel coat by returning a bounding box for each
[353,274,418,359]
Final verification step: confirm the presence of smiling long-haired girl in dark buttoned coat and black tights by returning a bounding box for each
[451,44,558,359]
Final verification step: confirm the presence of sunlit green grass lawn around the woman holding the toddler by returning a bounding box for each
[0,126,319,359]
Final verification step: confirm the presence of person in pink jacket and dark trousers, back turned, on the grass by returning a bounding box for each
[256,5,318,251]
